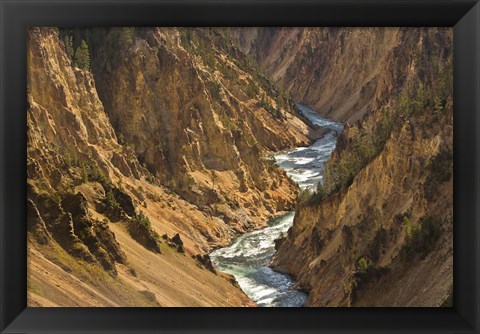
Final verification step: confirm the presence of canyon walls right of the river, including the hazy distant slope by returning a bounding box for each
[244,28,453,306]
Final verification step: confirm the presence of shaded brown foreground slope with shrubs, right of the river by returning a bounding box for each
[273,28,453,306]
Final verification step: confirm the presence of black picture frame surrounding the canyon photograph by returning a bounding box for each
[0,0,480,333]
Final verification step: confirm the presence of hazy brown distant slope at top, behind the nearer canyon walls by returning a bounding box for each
[230,27,438,124]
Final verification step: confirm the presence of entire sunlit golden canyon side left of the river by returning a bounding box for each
[27,28,318,306]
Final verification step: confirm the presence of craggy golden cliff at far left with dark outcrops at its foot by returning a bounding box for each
[27,29,134,273]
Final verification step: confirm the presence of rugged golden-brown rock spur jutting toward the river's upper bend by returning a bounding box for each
[88,28,315,232]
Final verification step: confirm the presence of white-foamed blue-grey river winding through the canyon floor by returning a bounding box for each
[210,104,343,307]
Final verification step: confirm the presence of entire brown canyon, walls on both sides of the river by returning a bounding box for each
[27,27,453,306]
